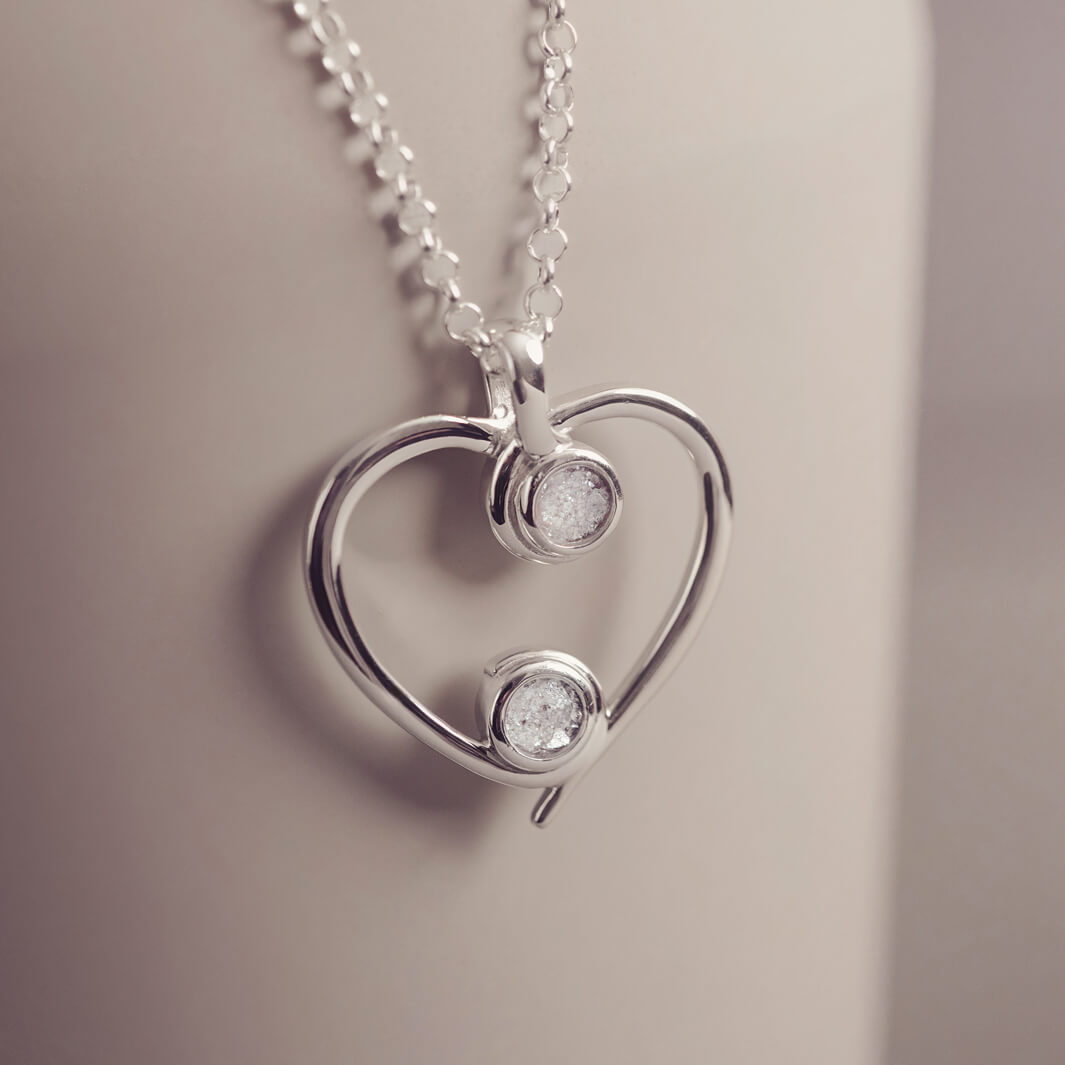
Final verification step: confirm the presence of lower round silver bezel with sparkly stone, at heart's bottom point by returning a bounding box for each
[479,651,603,772]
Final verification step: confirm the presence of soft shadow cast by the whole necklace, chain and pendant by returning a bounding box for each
[241,0,624,837]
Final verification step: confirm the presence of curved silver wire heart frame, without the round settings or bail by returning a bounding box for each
[305,389,733,825]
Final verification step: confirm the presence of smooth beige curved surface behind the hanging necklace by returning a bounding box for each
[0,0,927,1065]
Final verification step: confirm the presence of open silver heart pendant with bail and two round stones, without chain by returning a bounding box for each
[306,326,732,825]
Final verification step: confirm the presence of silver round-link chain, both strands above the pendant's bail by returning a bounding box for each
[291,0,577,358]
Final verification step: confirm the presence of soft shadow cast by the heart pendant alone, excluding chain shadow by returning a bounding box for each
[240,432,624,838]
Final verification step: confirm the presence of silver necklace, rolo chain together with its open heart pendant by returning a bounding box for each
[288,0,732,825]
